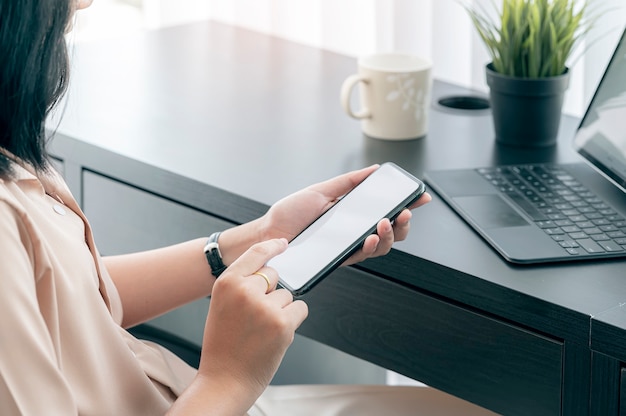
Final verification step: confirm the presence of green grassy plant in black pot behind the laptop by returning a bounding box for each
[465,0,596,147]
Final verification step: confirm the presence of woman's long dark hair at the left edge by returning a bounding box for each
[0,0,73,176]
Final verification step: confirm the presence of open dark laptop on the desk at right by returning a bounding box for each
[424,25,626,264]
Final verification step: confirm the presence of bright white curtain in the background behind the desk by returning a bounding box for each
[144,0,626,116]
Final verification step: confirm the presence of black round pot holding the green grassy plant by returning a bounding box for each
[486,64,569,147]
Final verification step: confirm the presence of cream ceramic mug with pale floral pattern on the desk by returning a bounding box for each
[341,53,432,140]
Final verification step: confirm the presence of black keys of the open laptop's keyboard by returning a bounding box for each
[476,165,626,256]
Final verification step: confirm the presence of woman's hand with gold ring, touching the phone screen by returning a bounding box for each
[191,239,308,414]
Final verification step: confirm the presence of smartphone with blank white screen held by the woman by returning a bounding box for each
[267,162,425,296]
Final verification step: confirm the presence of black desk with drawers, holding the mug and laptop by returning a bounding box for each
[53,23,626,415]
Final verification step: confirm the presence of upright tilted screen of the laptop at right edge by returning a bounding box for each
[574,26,626,192]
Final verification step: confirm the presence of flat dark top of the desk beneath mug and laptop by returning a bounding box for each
[53,22,626,416]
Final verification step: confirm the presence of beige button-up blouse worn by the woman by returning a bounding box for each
[0,161,195,416]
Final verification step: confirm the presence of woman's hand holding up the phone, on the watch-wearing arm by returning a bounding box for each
[261,165,431,265]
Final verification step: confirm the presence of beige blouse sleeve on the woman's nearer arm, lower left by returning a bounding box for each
[0,200,78,416]
